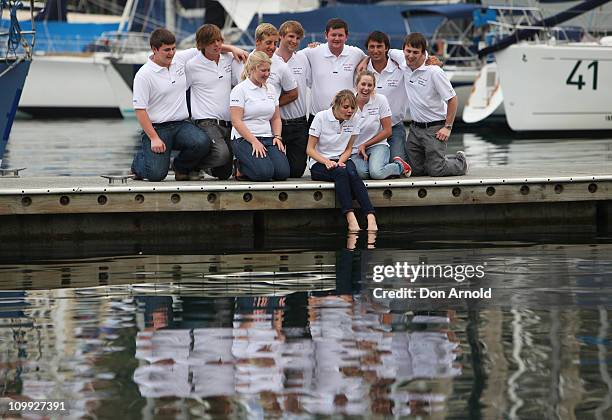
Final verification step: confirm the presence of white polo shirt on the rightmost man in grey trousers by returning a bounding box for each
[404,64,457,122]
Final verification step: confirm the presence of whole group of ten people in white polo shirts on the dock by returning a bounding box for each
[132,18,468,230]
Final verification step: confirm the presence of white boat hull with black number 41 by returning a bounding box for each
[495,42,612,131]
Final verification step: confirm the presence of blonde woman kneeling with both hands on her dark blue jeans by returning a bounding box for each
[230,51,289,181]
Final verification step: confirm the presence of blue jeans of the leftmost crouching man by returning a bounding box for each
[132,121,210,182]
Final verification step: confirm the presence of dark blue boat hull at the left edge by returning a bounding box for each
[0,60,30,159]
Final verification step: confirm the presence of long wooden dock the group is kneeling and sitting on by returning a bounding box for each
[0,162,612,238]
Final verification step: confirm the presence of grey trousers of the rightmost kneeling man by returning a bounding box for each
[406,125,467,176]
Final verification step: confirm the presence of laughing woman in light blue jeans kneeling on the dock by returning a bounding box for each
[351,70,411,179]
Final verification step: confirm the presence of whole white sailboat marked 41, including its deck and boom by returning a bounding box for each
[464,0,612,131]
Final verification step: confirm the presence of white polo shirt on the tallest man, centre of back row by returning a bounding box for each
[302,43,366,114]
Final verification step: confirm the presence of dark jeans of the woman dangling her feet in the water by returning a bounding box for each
[310,159,374,214]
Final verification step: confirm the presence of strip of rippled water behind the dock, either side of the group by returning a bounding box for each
[2,119,612,176]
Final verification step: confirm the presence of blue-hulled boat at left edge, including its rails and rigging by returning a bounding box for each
[0,0,33,160]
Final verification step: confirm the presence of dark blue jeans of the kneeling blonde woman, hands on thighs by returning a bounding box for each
[232,137,289,181]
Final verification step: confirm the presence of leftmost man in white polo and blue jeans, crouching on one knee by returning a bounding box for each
[132,29,210,181]
